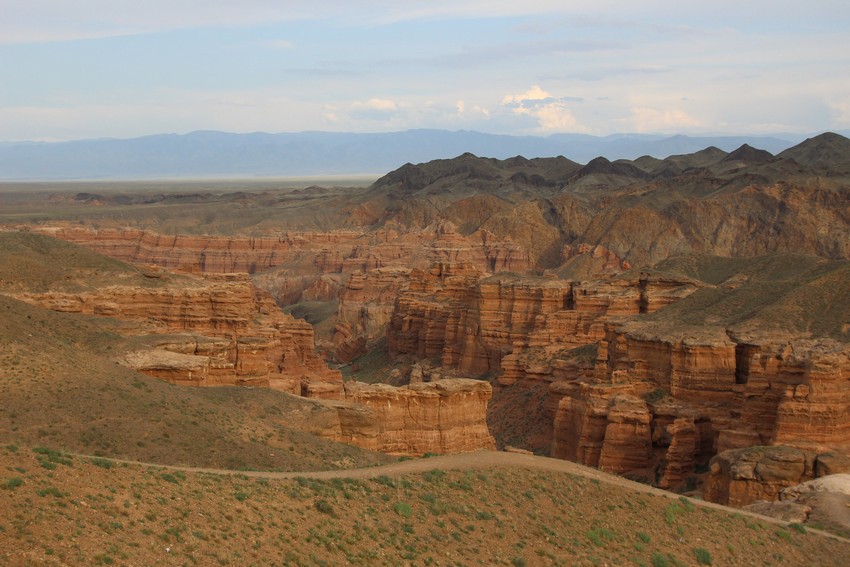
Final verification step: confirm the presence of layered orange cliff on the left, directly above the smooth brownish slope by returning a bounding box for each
[16,275,342,398]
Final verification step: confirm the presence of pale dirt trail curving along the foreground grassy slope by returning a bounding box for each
[80,451,850,543]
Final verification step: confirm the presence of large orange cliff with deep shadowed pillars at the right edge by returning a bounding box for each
[552,320,850,504]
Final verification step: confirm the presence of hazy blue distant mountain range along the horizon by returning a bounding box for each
[0,130,850,181]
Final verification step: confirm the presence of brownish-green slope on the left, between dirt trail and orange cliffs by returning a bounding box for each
[0,296,386,470]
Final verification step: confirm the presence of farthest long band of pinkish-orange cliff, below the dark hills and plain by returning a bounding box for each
[29,221,531,276]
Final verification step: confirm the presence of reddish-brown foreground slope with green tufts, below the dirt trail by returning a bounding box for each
[0,446,850,566]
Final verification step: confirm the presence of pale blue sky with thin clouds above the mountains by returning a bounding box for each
[0,0,850,141]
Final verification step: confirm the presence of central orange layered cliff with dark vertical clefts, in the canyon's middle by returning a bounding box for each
[388,272,696,385]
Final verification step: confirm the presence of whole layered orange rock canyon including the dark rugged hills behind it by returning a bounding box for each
[4,134,850,506]
